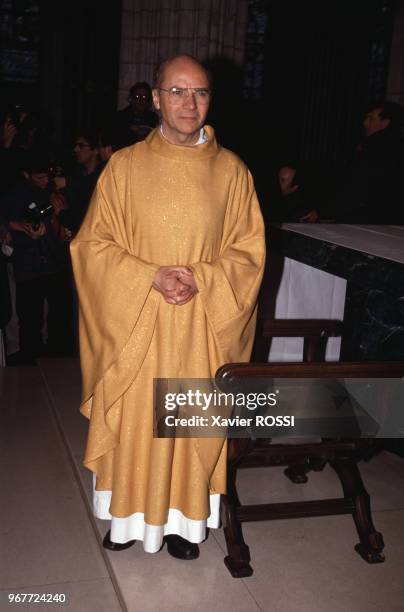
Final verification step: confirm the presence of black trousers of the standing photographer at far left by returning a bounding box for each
[16,272,73,357]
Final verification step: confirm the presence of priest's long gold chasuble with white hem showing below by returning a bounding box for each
[71,126,265,552]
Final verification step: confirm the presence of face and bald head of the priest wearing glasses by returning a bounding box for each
[153,58,209,145]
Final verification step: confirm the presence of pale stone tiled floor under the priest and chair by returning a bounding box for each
[0,360,404,612]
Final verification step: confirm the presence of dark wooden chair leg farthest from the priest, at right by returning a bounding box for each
[330,457,384,563]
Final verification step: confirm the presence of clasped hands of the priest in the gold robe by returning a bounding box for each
[153,266,198,306]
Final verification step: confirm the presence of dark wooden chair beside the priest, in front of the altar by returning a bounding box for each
[216,321,404,578]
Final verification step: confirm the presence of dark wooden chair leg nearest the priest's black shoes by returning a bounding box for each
[221,463,253,578]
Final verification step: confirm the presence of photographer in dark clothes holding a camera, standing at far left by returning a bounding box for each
[3,153,72,365]
